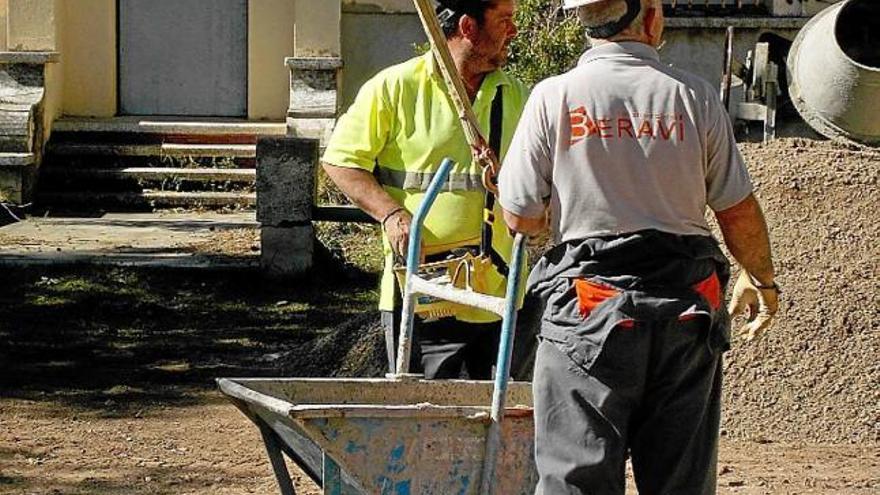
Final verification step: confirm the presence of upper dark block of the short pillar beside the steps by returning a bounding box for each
[257,137,318,227]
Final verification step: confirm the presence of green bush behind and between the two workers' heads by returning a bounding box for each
[507,0,586,86]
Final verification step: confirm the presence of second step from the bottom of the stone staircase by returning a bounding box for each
[44,167,257,184]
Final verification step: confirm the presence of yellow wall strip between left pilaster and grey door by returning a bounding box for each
[61,0,117,117]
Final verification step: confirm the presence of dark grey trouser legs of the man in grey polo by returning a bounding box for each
[533,318,722,495]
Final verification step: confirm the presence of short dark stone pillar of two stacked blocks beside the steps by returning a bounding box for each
[257,137,318,278]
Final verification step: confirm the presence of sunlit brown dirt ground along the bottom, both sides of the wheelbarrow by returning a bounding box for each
[0,400,880,495]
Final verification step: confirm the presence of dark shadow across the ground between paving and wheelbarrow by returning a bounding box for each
[0,254,382,416]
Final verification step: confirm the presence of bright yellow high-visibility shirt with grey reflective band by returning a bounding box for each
[322,52,528,322]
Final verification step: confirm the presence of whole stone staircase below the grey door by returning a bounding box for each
[37,117,286,213]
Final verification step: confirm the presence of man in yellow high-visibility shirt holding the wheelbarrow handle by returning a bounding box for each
[322,0,532,379]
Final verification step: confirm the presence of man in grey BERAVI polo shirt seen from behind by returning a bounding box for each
[499,0,778,495]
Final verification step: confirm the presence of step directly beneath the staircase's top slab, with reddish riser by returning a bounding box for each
[48,142,257,158]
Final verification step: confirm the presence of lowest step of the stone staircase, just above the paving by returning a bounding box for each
[38,190,257,209]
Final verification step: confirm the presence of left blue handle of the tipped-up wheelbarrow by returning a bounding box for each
[396,158,455,375]
